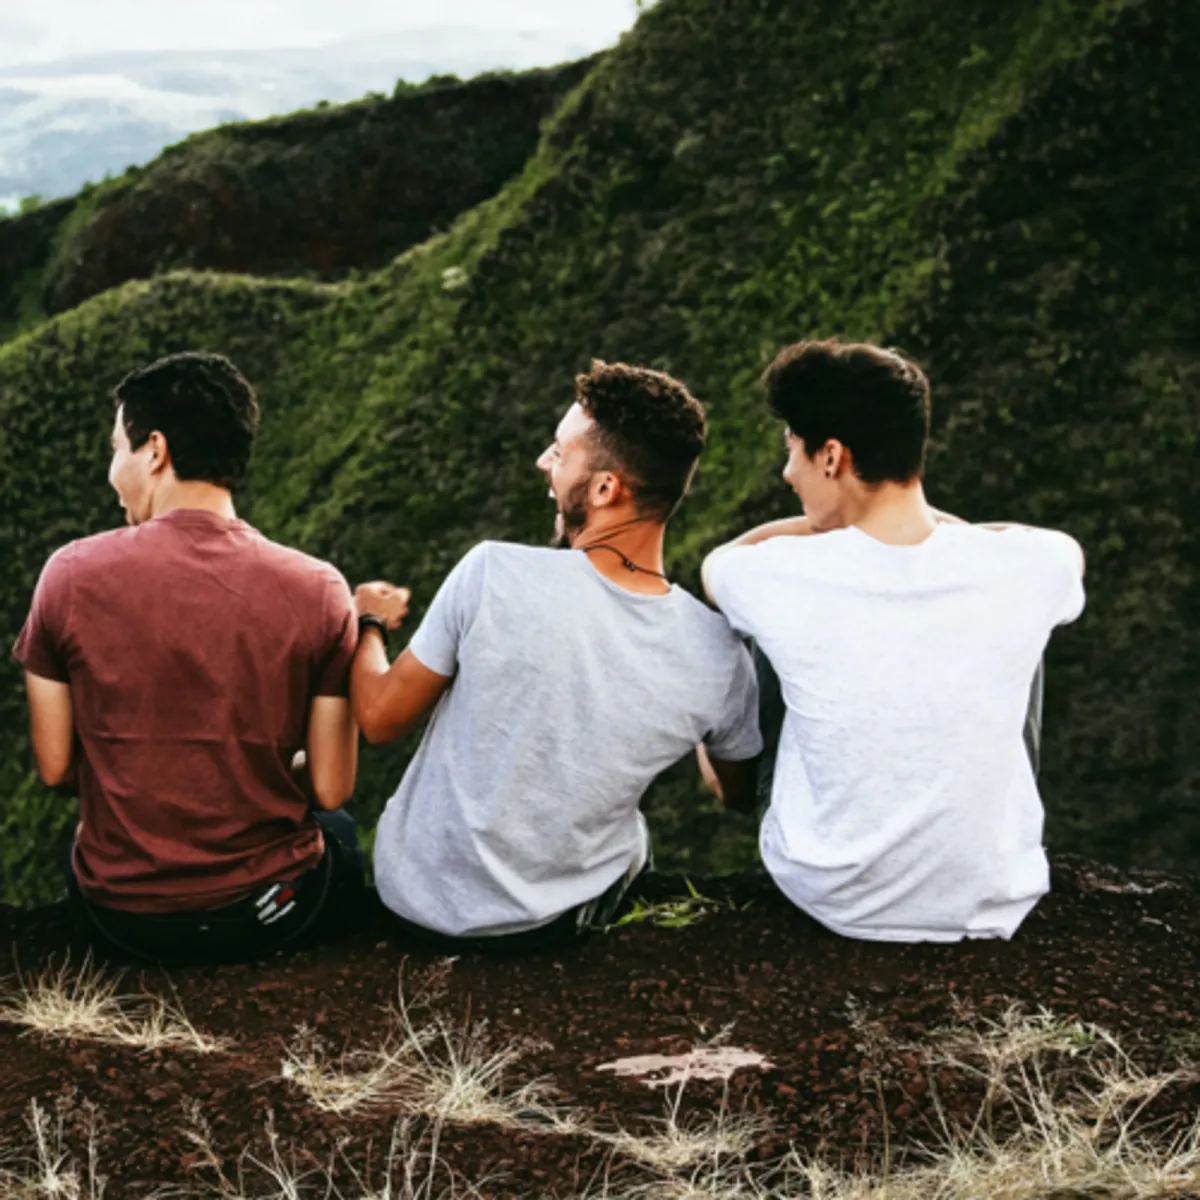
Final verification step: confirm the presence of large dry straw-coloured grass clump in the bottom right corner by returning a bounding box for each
[777,1007,1200,1200]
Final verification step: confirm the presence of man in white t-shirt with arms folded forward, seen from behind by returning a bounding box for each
[703,341,1084,942]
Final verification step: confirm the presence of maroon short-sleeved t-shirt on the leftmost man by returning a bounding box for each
[13,509,358,912]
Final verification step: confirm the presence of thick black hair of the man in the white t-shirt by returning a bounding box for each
[763,338,930,484]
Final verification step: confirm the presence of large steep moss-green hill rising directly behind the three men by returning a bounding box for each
[0,0,1200,900]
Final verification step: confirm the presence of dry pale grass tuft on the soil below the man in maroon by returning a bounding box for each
[0,958,227,1054]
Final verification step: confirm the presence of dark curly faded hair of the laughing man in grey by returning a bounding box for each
[575,359,708,521]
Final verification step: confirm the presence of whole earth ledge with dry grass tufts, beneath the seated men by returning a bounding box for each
[0,858,1200,1200]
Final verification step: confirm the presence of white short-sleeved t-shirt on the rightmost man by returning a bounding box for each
[708,524,1084,942]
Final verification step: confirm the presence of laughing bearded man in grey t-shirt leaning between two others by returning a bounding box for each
[352,362,762,948]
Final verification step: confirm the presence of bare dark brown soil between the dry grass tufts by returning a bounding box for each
[0,860,1200,1198]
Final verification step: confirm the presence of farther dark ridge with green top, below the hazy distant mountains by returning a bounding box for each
[0,60,594,336]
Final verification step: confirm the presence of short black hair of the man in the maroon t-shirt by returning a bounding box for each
[113,350,262,491]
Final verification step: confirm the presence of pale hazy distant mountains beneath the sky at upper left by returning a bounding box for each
[0,26,614,206]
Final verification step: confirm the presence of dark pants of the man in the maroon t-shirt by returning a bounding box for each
[66,811,365,964]
